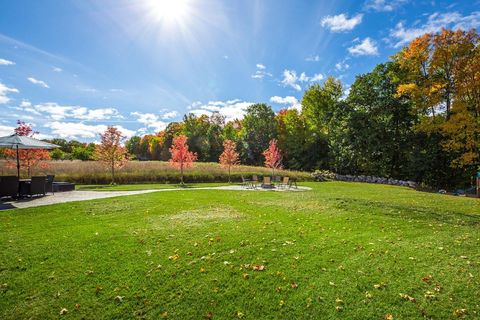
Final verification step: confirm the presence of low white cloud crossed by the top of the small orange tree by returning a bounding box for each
[45,121,135,139]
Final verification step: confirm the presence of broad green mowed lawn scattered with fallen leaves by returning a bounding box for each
[0,182,480,319]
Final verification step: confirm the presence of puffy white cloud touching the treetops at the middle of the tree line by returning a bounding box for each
[190,99,253,121]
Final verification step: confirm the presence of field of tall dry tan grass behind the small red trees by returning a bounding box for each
[0,160,311,184]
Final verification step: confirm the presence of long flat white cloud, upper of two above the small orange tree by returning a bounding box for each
[20,101,122,121]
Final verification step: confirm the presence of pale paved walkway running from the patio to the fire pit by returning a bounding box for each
[0,185,311,210]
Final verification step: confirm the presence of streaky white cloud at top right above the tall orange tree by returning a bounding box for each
[390,11,480,48]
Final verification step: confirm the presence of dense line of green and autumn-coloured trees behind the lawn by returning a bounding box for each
[126,29,480,187]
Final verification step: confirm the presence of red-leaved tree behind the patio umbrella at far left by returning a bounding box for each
[5,120,50,176]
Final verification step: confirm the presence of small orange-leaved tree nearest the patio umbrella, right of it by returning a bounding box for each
[94,126,128,184]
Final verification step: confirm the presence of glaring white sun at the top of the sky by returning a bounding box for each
[148,0,189,23]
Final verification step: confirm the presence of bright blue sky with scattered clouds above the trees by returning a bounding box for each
[0,0,480,141]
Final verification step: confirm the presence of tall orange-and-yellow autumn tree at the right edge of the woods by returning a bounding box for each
[395,29,480,171]
